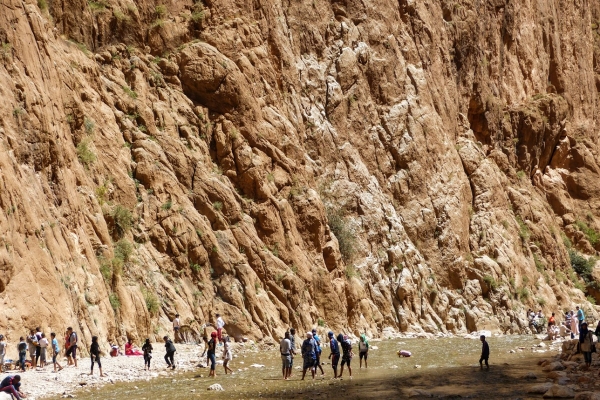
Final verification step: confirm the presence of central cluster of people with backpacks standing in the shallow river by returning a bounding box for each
[279,328,369,380]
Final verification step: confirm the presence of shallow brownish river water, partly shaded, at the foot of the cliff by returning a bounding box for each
[45,336,556,400]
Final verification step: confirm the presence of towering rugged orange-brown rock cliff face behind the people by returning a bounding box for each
[0,0,600,346]
